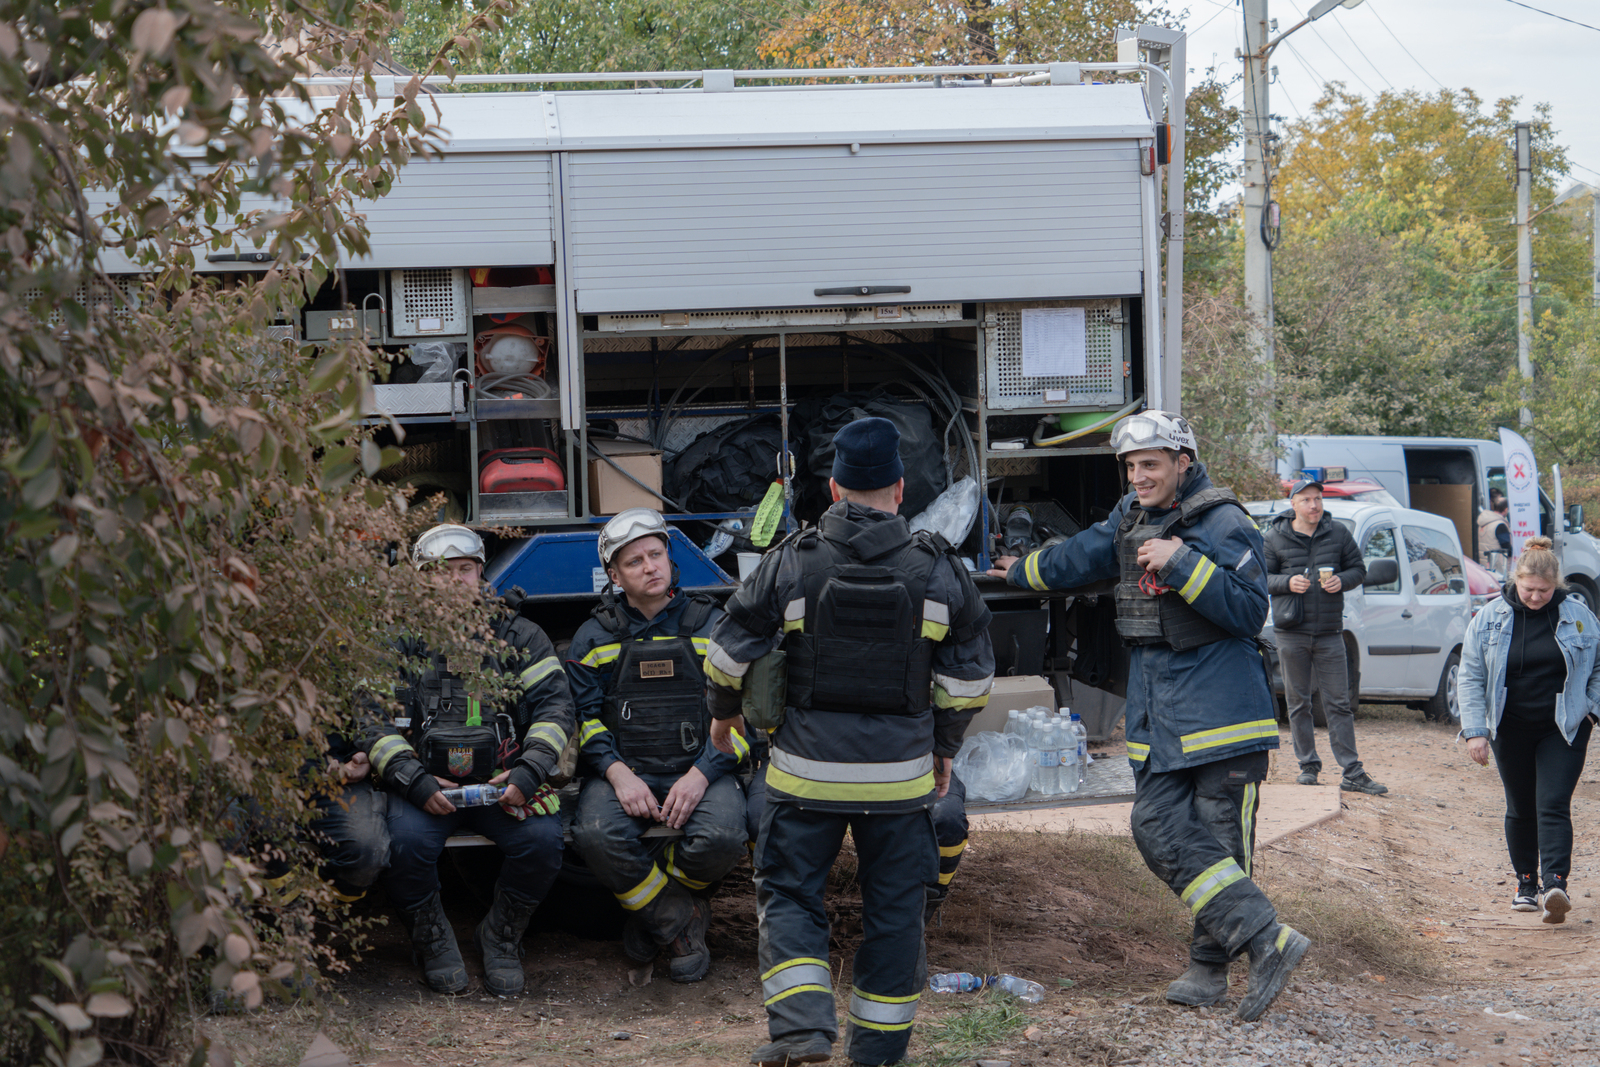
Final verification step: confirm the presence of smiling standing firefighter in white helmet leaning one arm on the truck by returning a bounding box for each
[990,411,1310,1021]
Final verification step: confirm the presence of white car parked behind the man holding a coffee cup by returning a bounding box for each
[1245,498,1472,726]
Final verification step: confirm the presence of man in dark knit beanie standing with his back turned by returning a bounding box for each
[706,418,994,1067]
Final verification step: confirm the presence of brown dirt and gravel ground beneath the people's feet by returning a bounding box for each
[200,710,1600,1067]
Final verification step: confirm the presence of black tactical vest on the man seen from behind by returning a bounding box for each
[784,514,944,715]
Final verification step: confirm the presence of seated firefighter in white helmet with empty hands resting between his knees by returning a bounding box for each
[566,507,744,982]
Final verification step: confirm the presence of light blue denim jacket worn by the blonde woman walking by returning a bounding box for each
[1461,597,1600,744]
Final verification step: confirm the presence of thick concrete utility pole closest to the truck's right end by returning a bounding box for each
[1242,0,1277,448]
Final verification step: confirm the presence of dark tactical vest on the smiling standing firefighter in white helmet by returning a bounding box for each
[1117,488,1243,651]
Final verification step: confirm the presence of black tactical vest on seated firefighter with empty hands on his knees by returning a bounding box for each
[594,593,717,774]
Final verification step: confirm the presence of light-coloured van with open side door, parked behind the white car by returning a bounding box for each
[1278,434,1600,609]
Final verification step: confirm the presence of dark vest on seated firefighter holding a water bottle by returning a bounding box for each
[395,654,517,782]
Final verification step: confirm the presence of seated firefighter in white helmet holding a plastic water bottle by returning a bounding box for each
[365,525,573,997]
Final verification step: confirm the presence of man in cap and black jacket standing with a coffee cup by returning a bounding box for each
[1262,478,1389,795]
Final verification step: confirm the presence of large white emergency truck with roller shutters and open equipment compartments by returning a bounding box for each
[87,27,1184,735]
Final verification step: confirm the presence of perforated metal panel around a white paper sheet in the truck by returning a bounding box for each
[986,301,1126,408]
